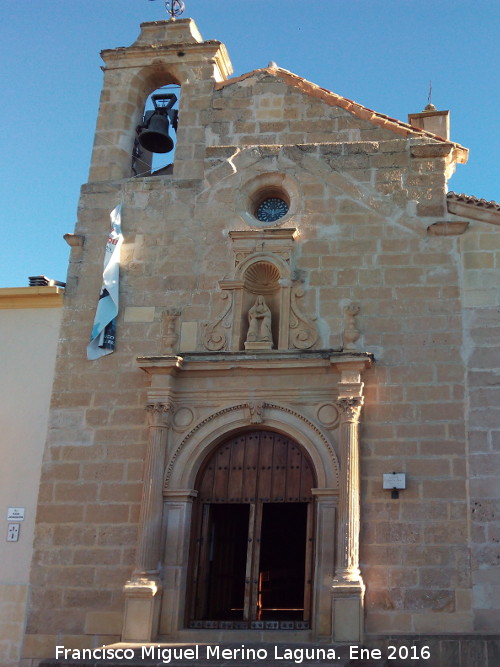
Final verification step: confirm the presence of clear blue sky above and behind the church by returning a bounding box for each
[0,0,500,287]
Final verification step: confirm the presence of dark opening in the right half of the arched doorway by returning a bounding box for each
[258,503,307,621]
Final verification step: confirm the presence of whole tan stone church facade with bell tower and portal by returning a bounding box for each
[22,19,500,667]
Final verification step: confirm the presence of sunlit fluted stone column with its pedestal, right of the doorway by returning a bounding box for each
[332,396,365,642]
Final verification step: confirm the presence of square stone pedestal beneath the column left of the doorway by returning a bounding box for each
[122,576,162,643]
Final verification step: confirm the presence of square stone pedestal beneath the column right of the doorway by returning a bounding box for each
[332,580,365,643]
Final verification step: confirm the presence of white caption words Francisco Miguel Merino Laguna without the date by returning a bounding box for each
[56,644,348,665]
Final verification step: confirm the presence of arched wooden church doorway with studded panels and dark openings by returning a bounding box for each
[189,430,316,629]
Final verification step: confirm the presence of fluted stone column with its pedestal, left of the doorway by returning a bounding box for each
[122,402,172,642]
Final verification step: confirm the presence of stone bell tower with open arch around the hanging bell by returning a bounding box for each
[89,19,232,182]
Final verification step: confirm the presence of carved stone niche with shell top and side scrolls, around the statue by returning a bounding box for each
[202,228,319,352]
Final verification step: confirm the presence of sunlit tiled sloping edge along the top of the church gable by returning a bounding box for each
[215,67,469,164]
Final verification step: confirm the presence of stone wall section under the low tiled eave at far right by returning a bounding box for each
[461,222,500,633]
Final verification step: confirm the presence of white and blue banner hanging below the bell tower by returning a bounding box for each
[87,204,123,359]
